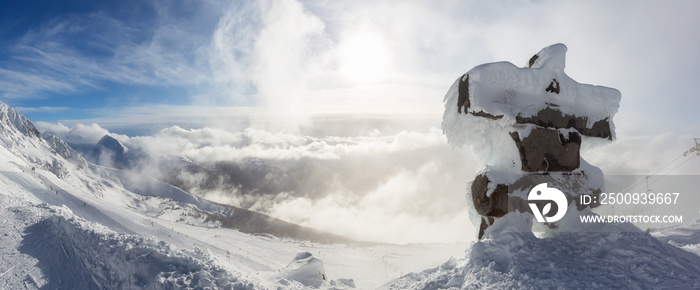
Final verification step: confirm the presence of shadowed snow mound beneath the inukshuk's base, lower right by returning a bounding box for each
[387,213,700,289]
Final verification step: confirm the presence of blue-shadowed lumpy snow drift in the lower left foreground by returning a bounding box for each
[19,207,256,289]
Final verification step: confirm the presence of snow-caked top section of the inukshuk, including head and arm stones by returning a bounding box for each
[442,43,621,150]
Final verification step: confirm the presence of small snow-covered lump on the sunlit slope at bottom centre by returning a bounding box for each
[282,252,326,288]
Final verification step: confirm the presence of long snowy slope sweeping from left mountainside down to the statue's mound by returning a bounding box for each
[0,103,465,289]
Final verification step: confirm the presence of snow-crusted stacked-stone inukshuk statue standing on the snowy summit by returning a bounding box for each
[442,44,620,239]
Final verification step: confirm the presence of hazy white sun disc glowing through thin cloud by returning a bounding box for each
[339,33,389,83]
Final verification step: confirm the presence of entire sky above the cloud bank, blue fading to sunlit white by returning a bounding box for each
[0,0,700,134]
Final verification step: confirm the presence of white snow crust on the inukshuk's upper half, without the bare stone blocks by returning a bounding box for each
[442,44,621,170]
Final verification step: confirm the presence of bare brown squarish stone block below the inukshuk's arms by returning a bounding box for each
[510,128,581,172]
